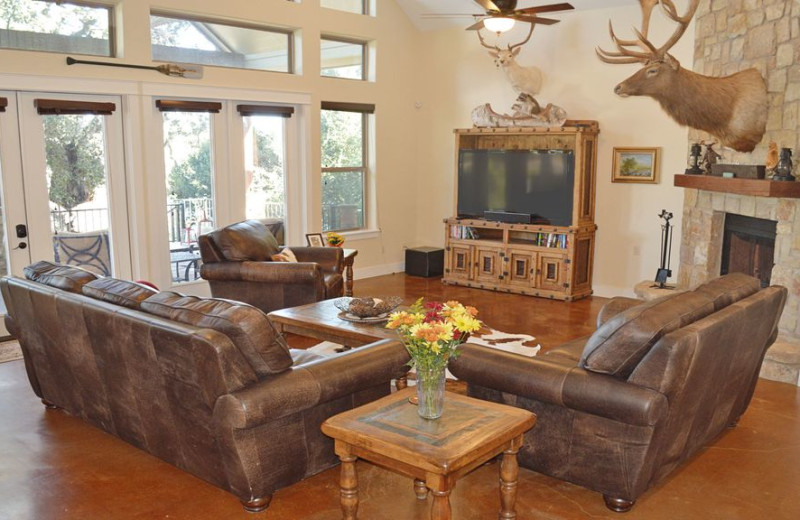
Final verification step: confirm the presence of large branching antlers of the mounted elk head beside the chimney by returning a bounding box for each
[595,0,700,63]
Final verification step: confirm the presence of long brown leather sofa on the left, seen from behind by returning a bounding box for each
[0,262,409,511]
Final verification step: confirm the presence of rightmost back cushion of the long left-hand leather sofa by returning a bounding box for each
[141,291,293,376]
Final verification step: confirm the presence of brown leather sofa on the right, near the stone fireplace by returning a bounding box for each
[450,274,787,512]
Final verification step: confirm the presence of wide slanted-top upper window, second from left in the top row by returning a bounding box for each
[150,12,292,73]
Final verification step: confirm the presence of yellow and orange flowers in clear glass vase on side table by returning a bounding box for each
[386,298,483,419]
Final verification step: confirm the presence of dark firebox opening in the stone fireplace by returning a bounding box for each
[720,213,778,287]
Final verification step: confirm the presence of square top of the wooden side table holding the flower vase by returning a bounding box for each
[322,388,536,475]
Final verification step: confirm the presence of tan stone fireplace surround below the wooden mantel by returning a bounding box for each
[678,189,800,384]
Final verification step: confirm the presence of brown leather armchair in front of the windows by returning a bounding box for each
[199,220,344,312]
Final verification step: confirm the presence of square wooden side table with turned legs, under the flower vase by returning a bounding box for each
[322,388,536,520]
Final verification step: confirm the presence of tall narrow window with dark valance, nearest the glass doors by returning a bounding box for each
[156,100,222,282]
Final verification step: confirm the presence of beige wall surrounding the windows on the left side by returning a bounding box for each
[0,0,419,279]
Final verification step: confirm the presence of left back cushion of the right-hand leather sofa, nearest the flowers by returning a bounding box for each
[580,291,714,379]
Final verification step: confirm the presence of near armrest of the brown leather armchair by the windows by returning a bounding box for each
[200,262,323,286]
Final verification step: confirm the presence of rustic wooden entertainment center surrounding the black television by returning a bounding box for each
[442,120,600,301]
